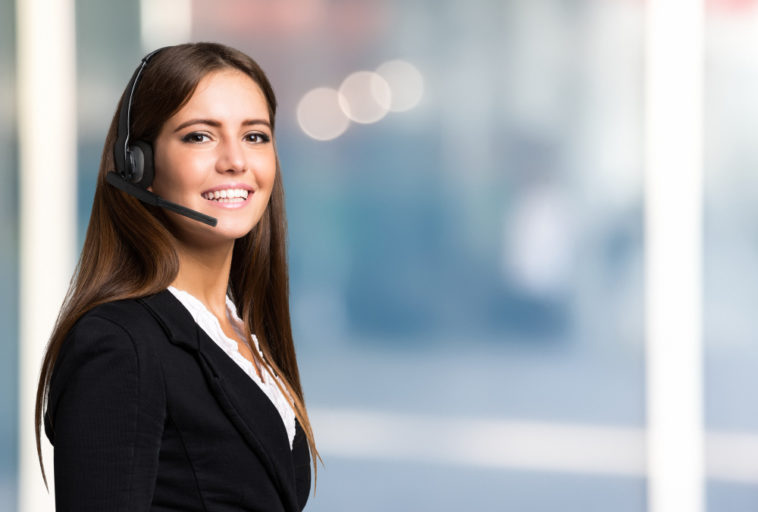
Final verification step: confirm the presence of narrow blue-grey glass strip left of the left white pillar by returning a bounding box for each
[0,0,18,510]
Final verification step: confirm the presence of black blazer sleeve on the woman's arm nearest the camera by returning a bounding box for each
[46,314,166,512]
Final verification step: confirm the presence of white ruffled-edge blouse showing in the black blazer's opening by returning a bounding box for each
[168,286,295,449]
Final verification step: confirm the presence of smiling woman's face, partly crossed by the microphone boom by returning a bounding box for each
[151,69,276,243]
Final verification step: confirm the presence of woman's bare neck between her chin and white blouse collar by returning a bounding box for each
[171,240,234,318]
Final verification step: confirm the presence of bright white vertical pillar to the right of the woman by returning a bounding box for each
[645,0,705,512]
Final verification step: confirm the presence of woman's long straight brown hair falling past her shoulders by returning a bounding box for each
[35,43,320,484]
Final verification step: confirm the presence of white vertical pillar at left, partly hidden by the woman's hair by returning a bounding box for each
[16,0,76,512]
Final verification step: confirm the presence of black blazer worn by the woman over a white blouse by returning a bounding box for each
[45,290,311,512]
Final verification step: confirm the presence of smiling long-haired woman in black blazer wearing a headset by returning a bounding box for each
[31,43,318,512]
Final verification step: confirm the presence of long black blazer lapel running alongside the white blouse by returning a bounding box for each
[140,290,299,511]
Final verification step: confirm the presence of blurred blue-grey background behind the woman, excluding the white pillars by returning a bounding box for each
[0,0,758,512]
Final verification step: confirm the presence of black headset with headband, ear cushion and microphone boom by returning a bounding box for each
[105,48,218,226]
